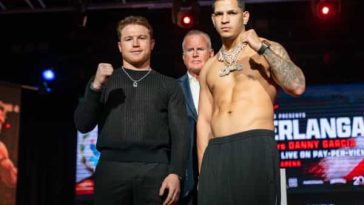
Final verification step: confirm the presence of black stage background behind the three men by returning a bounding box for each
[0,0,364,205]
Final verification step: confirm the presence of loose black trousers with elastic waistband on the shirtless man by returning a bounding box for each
[198,130,280,205]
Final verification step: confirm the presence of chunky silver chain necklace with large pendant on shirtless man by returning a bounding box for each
[218,43,246,77]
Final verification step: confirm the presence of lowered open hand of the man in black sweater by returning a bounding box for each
[159,174,181,205]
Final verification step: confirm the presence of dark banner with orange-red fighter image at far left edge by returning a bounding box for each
[0,83,21,205]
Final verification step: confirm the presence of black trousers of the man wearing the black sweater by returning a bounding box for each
[95,161,168,205]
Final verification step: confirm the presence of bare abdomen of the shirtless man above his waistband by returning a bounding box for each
[211,80,274,137]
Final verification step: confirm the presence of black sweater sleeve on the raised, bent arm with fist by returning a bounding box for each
[74,80,102,133]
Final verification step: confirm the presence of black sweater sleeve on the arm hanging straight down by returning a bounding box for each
[168,82,191,177]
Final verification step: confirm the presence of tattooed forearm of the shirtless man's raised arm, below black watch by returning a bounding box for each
[263,43,305,92]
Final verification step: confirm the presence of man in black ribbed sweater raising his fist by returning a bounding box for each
[75,16,190,205]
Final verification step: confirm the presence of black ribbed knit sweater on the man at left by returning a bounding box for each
[74,68,190,176]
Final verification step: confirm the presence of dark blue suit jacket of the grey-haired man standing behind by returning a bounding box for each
[178,73,198,198]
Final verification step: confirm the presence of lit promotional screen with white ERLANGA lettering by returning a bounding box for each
[274,84,364,193]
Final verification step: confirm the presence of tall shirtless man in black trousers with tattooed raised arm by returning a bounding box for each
[197,0,305,205]
